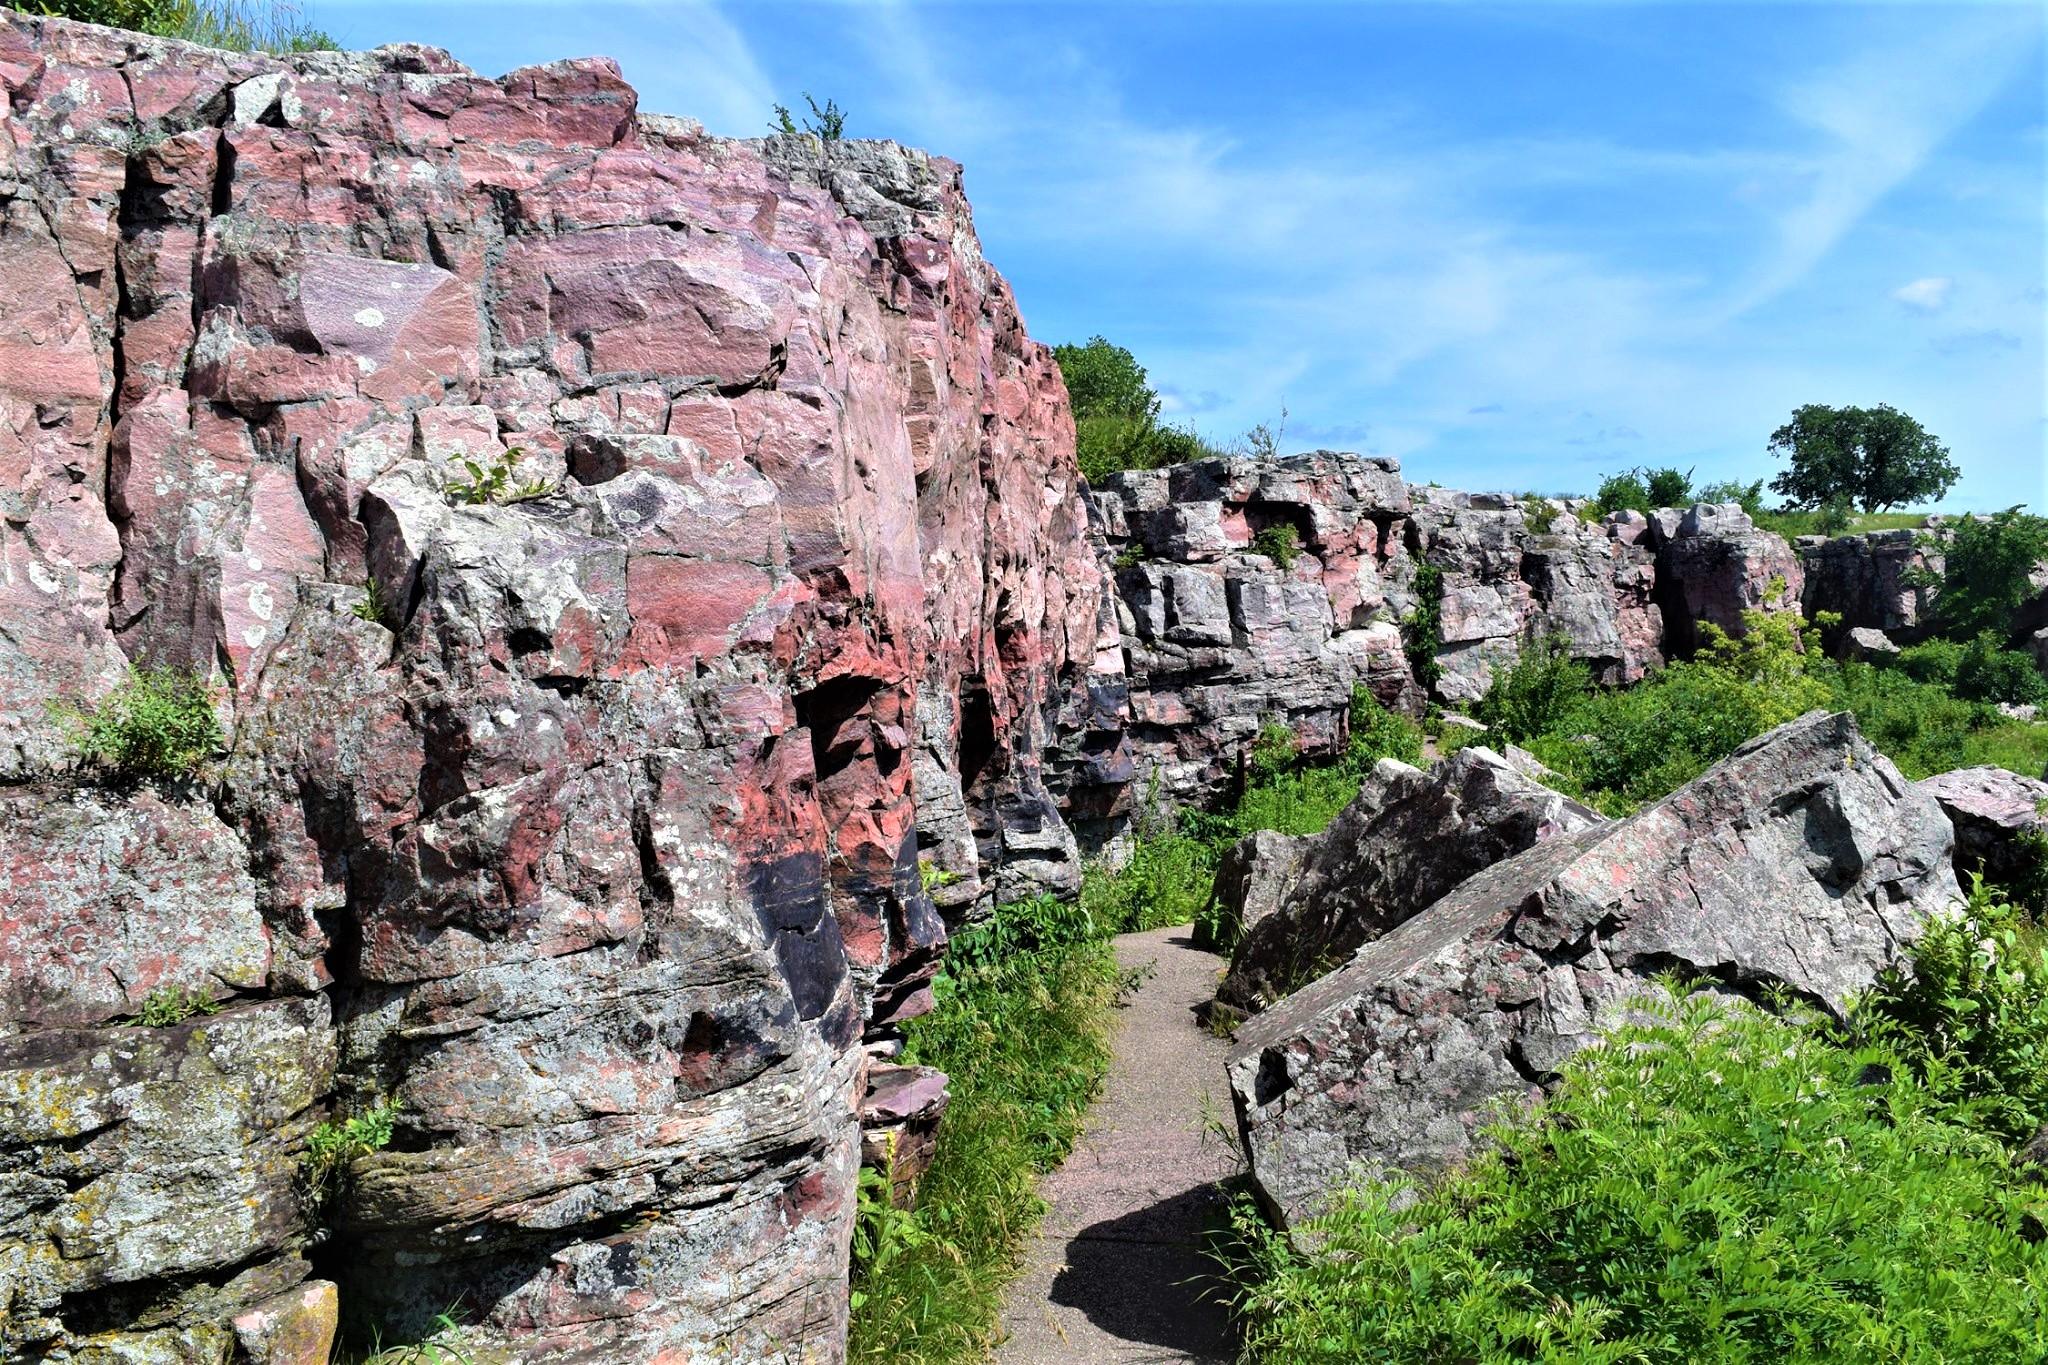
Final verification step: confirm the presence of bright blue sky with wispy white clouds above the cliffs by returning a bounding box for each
[327,0,2048,508]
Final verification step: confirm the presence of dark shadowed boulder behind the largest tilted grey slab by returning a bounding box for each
[1217,745,1602,1013]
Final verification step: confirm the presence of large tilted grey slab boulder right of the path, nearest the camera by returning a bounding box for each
[1229,712,1956,1220]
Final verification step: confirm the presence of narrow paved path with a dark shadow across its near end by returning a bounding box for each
[995,927,1235,1365]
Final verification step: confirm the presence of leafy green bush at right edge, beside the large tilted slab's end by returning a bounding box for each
[1851,876,2048,1144]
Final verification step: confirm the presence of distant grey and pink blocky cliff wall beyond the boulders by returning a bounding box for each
[1094,464,1800,818]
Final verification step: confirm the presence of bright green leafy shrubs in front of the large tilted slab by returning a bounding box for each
[1239,995,2048,1365]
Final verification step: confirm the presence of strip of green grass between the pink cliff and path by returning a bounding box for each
[850,905,1130,1365]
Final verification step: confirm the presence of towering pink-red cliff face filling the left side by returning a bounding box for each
[0,10,1130,1361]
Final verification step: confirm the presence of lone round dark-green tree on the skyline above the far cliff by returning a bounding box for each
[1769,403,1960,512]
